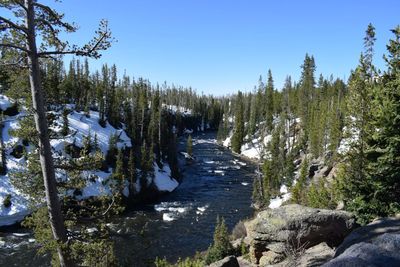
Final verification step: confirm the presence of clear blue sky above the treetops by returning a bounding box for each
[45,0,400,95]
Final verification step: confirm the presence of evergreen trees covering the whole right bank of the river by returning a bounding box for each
[218,25,400,223]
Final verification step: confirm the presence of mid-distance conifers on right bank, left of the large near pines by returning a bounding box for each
[218,55,347,204]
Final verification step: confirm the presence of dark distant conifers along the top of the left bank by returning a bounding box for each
[0,59,223,185]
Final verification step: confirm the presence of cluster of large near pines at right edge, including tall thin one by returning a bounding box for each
[342,26,400,223]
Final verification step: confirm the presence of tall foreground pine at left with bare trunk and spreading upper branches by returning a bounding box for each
[0,0,110,266]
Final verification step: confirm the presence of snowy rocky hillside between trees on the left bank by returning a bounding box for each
[0,95,179,226]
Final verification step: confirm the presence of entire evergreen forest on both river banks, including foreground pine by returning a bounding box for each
[0,0,400,266]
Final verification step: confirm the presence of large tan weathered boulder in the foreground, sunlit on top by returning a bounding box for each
[245,204,357,265]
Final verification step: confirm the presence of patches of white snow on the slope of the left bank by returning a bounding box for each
[0,95,179,226]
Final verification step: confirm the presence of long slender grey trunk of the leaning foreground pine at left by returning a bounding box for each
[25,0,73,266]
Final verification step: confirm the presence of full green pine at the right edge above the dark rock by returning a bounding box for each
[346,26,400,223]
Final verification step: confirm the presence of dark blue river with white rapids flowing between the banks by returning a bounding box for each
[0,134,255,267]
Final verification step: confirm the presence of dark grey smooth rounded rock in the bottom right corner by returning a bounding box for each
[324,218,400,267]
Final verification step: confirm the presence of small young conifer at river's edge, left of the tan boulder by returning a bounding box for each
[205,216,233,264]
